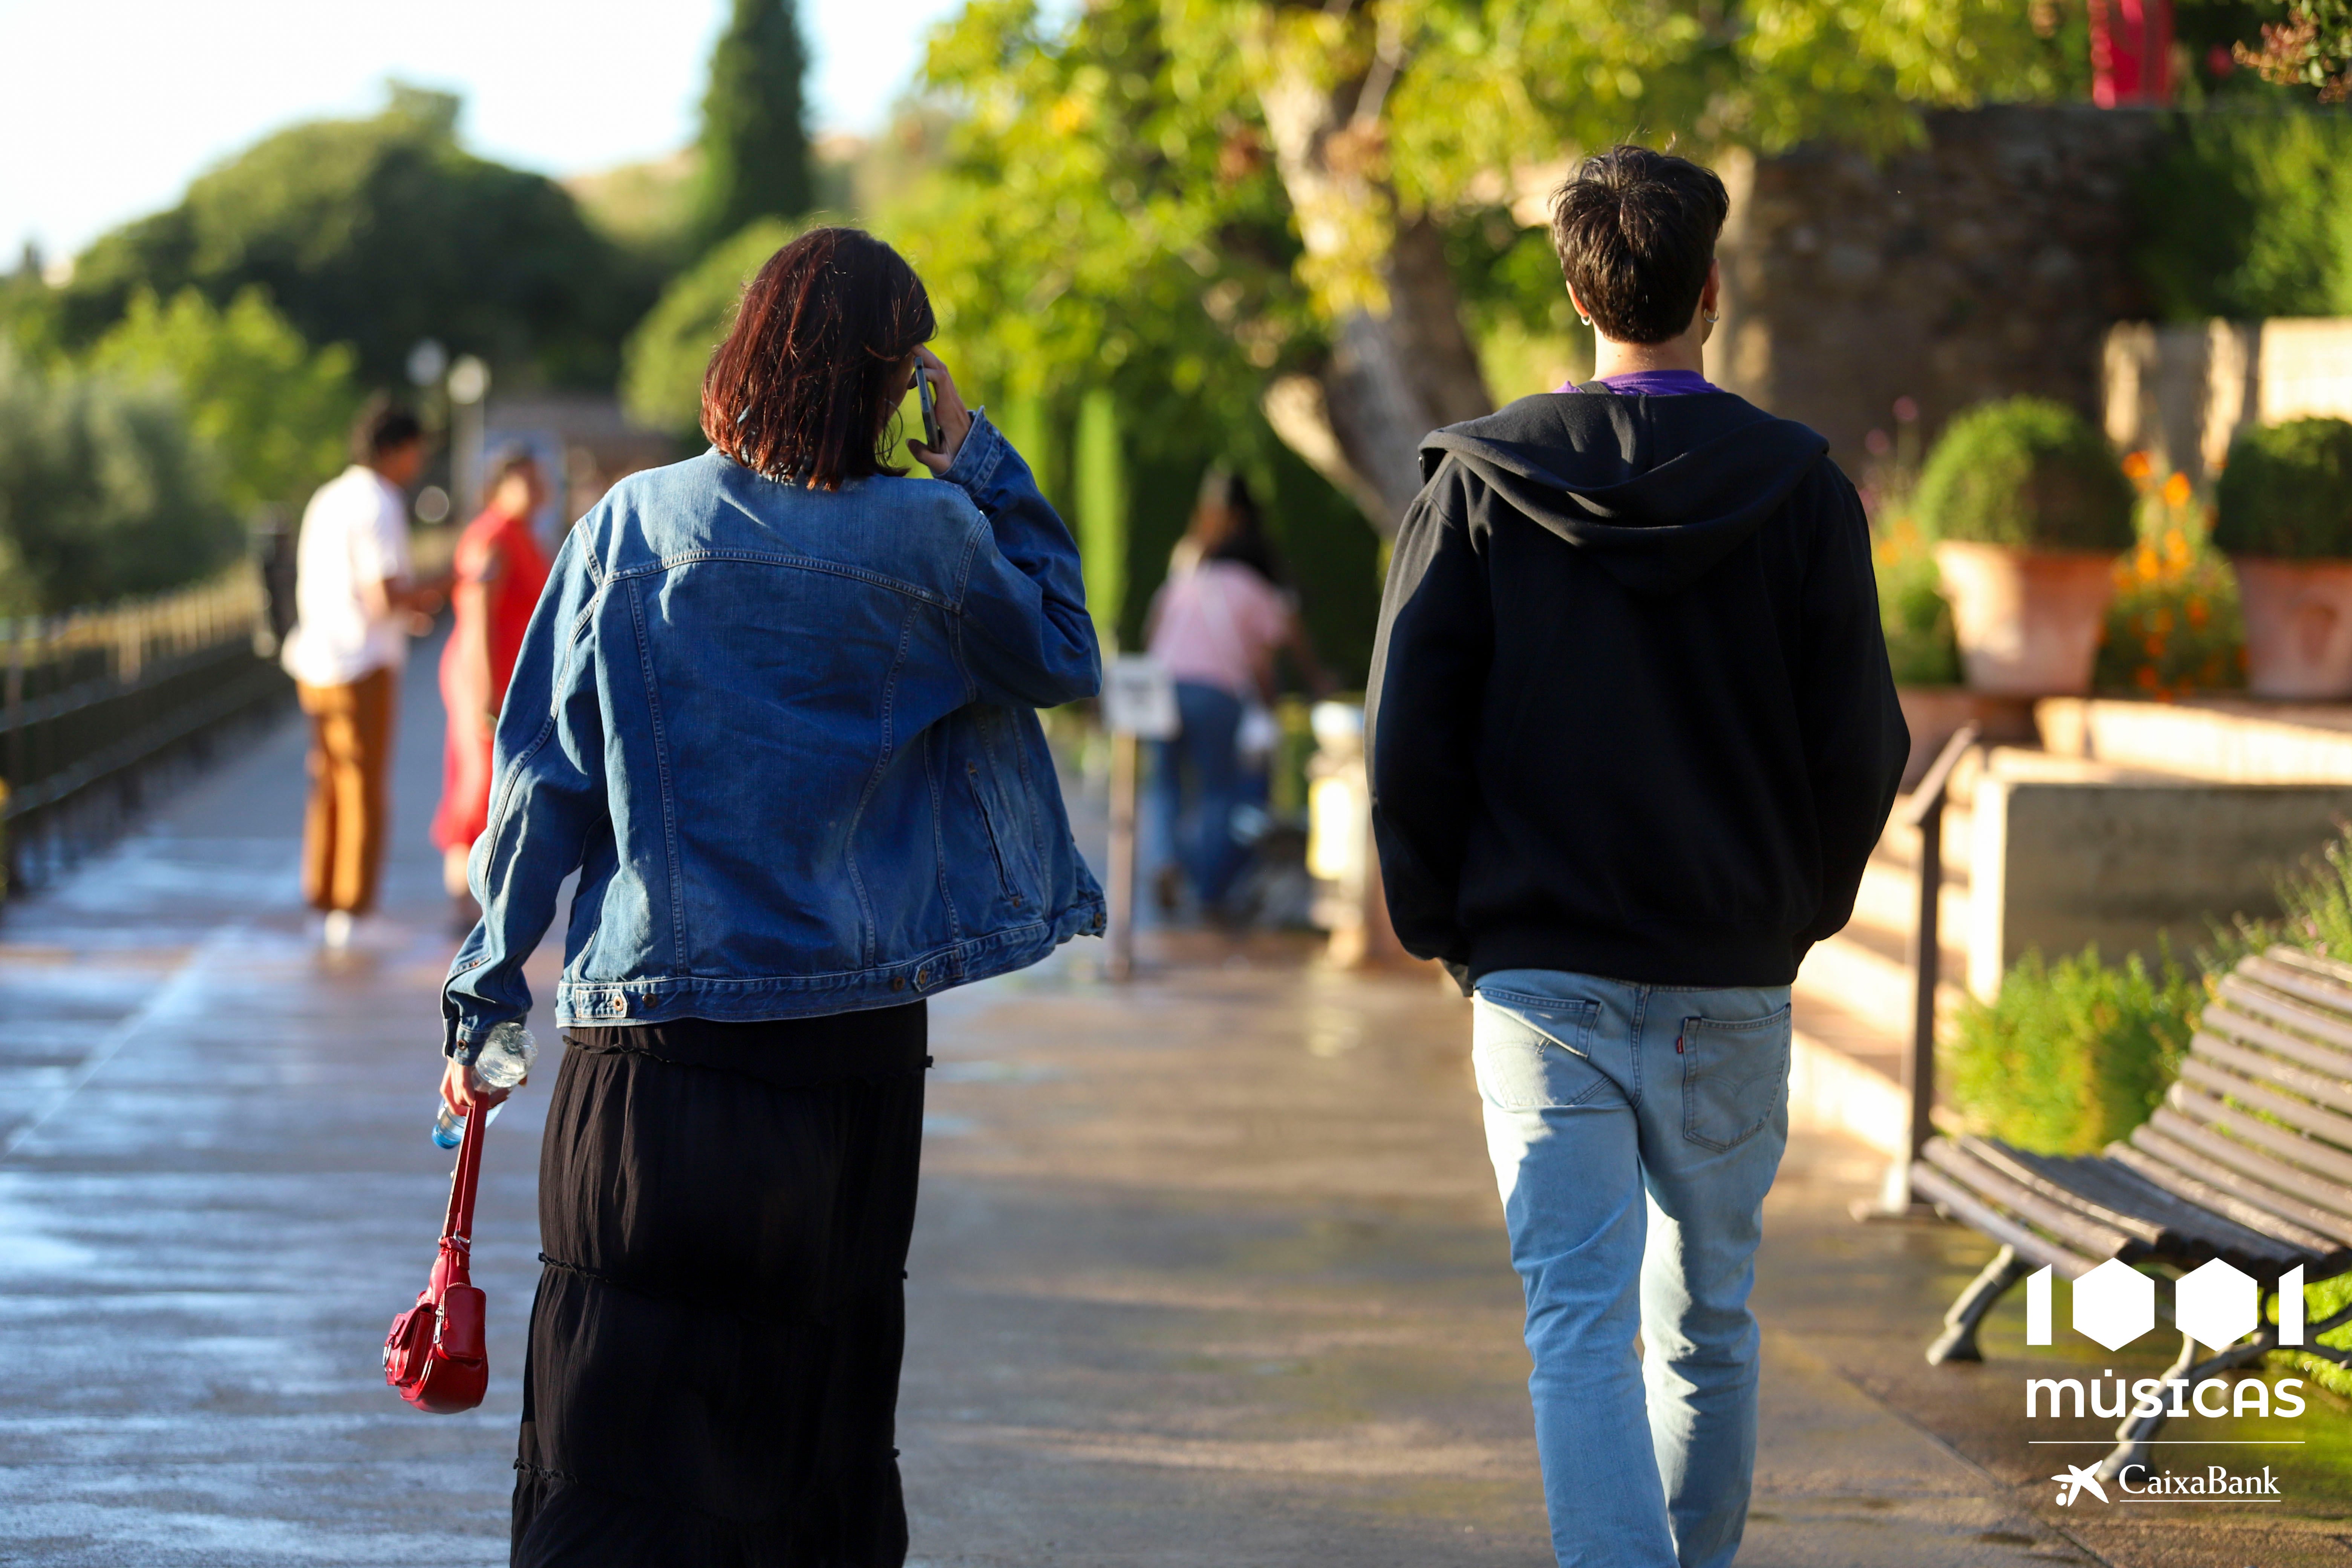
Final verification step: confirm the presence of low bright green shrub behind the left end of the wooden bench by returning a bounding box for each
[1945,947,2206,1154]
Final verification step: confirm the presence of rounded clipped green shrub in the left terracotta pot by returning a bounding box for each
[1917,397,2136,550]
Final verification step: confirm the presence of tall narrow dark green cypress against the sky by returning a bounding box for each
[696,0,812,245]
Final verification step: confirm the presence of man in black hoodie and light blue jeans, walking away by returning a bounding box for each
[1366,146,1910,1568]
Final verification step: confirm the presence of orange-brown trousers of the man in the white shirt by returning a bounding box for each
[299,670,398,914]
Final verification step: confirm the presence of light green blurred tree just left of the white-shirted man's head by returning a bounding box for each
[87,287,360,515]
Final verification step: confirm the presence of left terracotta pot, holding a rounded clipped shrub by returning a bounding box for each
[1936,541,2115,696]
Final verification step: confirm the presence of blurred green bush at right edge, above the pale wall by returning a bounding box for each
[2133,113,2352,322]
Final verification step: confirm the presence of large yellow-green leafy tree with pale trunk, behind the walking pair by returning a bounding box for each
[887,0,2084,529]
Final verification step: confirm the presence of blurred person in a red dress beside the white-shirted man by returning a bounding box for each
[433,451,548,929]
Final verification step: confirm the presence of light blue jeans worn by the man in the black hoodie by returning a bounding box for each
[1472,969,1790,1568]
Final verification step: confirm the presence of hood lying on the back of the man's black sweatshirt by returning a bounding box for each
[1421,390,1830,593]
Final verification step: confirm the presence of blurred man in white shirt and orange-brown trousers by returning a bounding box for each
[285,397,428,947]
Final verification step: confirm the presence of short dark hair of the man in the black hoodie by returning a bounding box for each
[1552,146,1731,343]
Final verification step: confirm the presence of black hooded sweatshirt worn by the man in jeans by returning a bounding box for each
[1364,383,1910,990]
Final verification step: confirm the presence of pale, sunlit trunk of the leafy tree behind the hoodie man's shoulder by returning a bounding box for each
[1261,73,1493,538]
